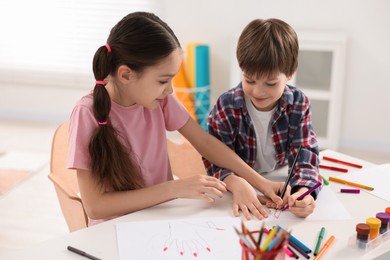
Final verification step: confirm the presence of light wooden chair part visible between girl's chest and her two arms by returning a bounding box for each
[167,137,206,178]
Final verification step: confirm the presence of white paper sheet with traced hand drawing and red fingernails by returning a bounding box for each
[116,217,241,260]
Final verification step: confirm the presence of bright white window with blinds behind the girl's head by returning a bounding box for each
[0,0,162,88]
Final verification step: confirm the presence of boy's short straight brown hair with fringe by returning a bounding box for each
[236,18,299,78]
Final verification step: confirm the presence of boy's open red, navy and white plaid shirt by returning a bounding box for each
[203,83,322,197]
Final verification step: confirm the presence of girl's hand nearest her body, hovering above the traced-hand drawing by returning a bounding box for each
[172,175,227,202]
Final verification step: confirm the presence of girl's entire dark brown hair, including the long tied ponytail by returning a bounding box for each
[89,12,180,191]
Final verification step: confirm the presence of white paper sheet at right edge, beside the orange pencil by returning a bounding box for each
[337,163,390,202]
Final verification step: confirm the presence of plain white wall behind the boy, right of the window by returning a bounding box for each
[165,0,390,152]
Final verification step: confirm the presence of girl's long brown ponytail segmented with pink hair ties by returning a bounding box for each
[89,44,144,191]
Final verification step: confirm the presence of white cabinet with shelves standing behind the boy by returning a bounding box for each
[230,31,347,150]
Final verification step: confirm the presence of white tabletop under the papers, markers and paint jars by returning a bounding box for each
[0,150,390,260]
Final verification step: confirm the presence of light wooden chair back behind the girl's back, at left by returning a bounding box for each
[49,122,88,232]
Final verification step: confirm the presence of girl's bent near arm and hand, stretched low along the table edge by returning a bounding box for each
[77,169,226,219]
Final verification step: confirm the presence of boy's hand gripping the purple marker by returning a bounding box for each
[288,187,316,218]
